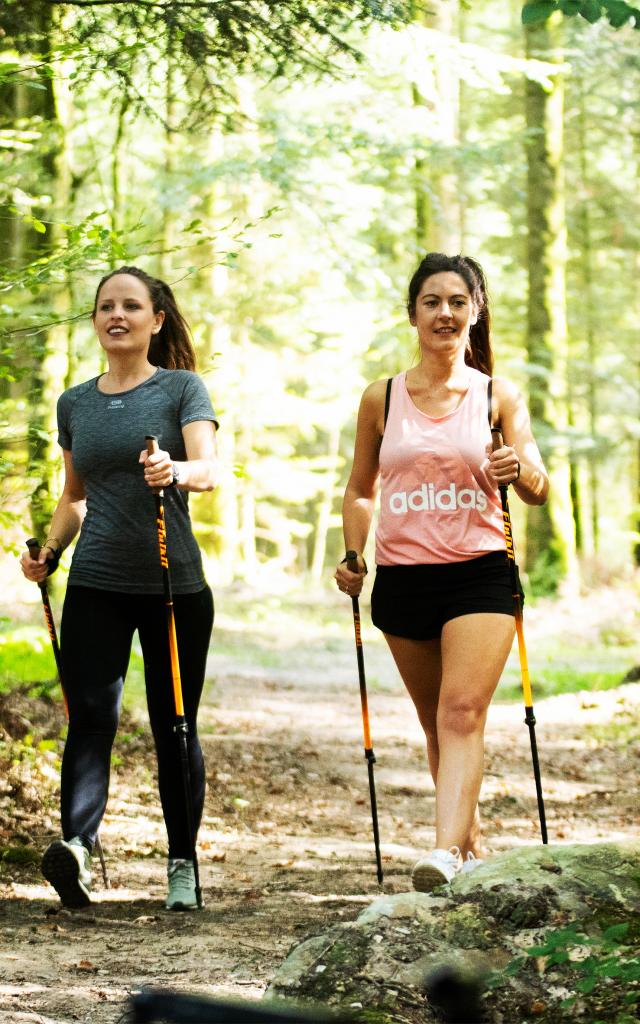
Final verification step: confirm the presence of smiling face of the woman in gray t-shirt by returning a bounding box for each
[93,273,165,354]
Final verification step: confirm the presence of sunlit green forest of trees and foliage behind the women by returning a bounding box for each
[0,0,640,591]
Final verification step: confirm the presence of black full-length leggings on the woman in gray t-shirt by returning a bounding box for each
[60,586,213,859]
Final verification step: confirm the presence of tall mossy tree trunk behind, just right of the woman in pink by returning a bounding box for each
[525,12,577,592]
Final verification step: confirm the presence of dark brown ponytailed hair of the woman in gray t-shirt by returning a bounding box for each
[91,266,196,370]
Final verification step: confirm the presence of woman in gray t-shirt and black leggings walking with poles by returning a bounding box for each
[22,267,218,909]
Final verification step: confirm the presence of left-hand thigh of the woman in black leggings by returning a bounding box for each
[60,586,135,724]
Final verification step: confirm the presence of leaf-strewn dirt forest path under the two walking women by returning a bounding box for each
[0,585,640,1024]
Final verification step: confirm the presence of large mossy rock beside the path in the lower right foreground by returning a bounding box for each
[267,842,640,1024]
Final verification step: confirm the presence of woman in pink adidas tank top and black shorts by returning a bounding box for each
[336,253,549,892]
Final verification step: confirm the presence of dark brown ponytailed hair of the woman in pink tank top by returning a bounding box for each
[407,253,494,377]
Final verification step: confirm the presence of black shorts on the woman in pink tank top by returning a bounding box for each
[371,551,522,640]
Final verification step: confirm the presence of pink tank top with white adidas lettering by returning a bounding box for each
[376,367,505,565]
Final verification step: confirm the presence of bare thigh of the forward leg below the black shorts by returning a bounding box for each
[440,612,515,711]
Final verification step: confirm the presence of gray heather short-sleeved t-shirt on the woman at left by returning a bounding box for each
[57,368,217,594]
